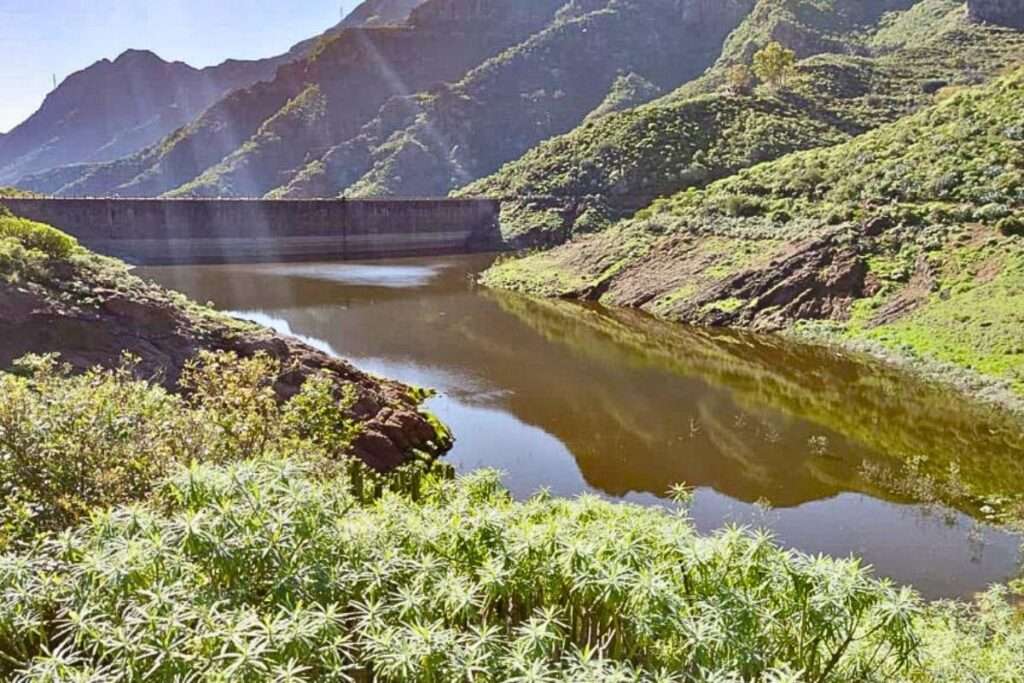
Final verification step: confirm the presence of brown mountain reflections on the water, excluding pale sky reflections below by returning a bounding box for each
[142,258,1024,507]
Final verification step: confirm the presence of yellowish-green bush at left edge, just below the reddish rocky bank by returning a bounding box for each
[0,353,355,550]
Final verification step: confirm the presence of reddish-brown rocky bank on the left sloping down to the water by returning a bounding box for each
[0,257,451,471]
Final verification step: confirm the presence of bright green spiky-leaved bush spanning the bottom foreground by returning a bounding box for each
[0,461,921,682]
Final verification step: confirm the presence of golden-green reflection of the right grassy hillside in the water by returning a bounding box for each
[495,293,1024,501]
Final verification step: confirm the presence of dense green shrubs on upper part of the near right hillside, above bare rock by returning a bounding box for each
[652,72,1024,224]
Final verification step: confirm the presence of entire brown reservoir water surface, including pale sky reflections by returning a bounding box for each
[138,256,1024,597]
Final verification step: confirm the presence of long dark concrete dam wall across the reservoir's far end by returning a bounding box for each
[0,199,502,264]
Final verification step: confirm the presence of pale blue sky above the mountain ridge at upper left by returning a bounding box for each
[0,0,357,132]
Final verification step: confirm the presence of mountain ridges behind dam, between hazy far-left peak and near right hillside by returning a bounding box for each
[14,0,1021,206]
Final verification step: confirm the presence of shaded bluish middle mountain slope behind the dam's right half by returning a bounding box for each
[275,0,753,197]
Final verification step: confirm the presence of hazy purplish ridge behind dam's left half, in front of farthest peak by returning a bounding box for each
[22,0,563,196]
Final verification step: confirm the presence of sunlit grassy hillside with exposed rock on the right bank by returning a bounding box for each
[485,62,1024,405]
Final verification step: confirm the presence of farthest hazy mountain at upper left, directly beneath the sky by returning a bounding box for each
[0,0,421,189]
